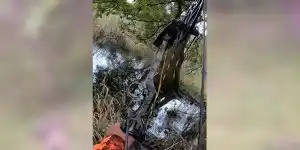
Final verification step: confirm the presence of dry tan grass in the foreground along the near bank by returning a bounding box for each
[93,79,202,150]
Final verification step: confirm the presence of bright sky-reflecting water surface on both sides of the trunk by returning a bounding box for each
[93,43,200,139]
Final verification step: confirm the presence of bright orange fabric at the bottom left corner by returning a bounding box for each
[93,135,125,150]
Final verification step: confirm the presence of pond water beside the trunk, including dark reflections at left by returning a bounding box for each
[93,44,200,139]
